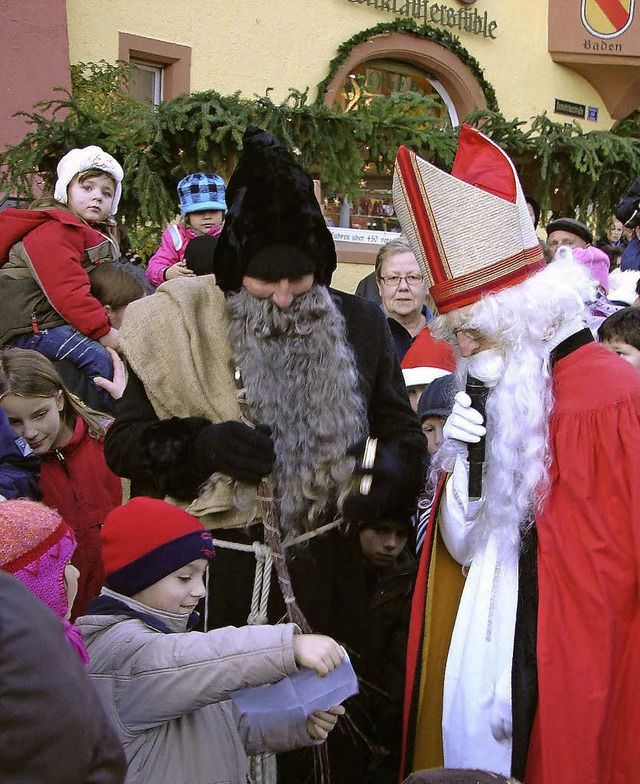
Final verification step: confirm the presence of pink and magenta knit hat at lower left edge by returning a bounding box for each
[0,500,76,620]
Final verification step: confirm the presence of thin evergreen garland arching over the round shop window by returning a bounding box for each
[316,18,498,112]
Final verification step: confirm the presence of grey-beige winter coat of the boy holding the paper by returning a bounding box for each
[77,588,314,784]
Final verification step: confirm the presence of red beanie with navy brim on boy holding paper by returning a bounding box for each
[100,497,213,596]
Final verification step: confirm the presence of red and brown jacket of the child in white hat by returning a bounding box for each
[0,208,117,342]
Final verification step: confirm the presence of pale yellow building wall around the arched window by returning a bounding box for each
[67,0,612,130]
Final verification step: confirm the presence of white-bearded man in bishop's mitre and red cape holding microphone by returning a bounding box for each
[394,126,640,784]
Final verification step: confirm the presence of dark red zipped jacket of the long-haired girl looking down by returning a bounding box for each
[40,416,122,619]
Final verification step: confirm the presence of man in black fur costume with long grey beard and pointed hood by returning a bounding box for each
[105,126,424,782]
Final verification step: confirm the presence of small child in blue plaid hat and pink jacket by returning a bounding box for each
[147,172,227,287]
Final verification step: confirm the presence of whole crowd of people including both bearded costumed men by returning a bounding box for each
[0,126,640,784]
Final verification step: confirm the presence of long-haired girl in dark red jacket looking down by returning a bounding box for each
[0,348,122,620]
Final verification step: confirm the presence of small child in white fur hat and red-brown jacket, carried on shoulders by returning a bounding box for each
[0,146,123,412]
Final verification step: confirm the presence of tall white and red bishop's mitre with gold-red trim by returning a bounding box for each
[393,125,545,313]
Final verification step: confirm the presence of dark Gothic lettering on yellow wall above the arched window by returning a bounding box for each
[348,0,498,40]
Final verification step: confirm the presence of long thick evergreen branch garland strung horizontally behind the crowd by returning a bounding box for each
[0,59,640,256]
